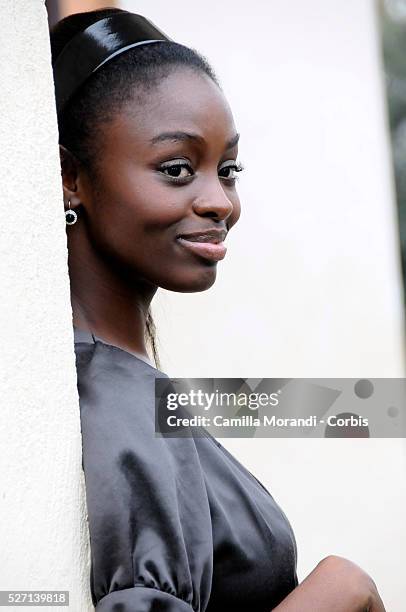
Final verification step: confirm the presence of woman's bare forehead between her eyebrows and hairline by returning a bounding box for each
[108,69,236,146]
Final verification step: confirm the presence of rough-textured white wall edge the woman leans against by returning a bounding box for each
[0,0,93,612]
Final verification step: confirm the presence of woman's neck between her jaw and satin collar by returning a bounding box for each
[68,227,157,359]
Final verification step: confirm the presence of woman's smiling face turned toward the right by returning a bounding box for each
[76,69,240,292]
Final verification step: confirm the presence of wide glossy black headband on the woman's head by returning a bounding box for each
[53,12,171,115]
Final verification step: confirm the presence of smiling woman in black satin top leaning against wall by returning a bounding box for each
[51,9,384,612]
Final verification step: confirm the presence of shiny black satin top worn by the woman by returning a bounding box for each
[74,328,297,612]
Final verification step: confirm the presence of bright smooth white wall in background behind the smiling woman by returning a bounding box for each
[117,0,406,612]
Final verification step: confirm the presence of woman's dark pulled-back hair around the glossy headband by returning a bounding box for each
[50,8,220,367]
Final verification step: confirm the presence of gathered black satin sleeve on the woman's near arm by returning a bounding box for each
[77,343,213,612]
